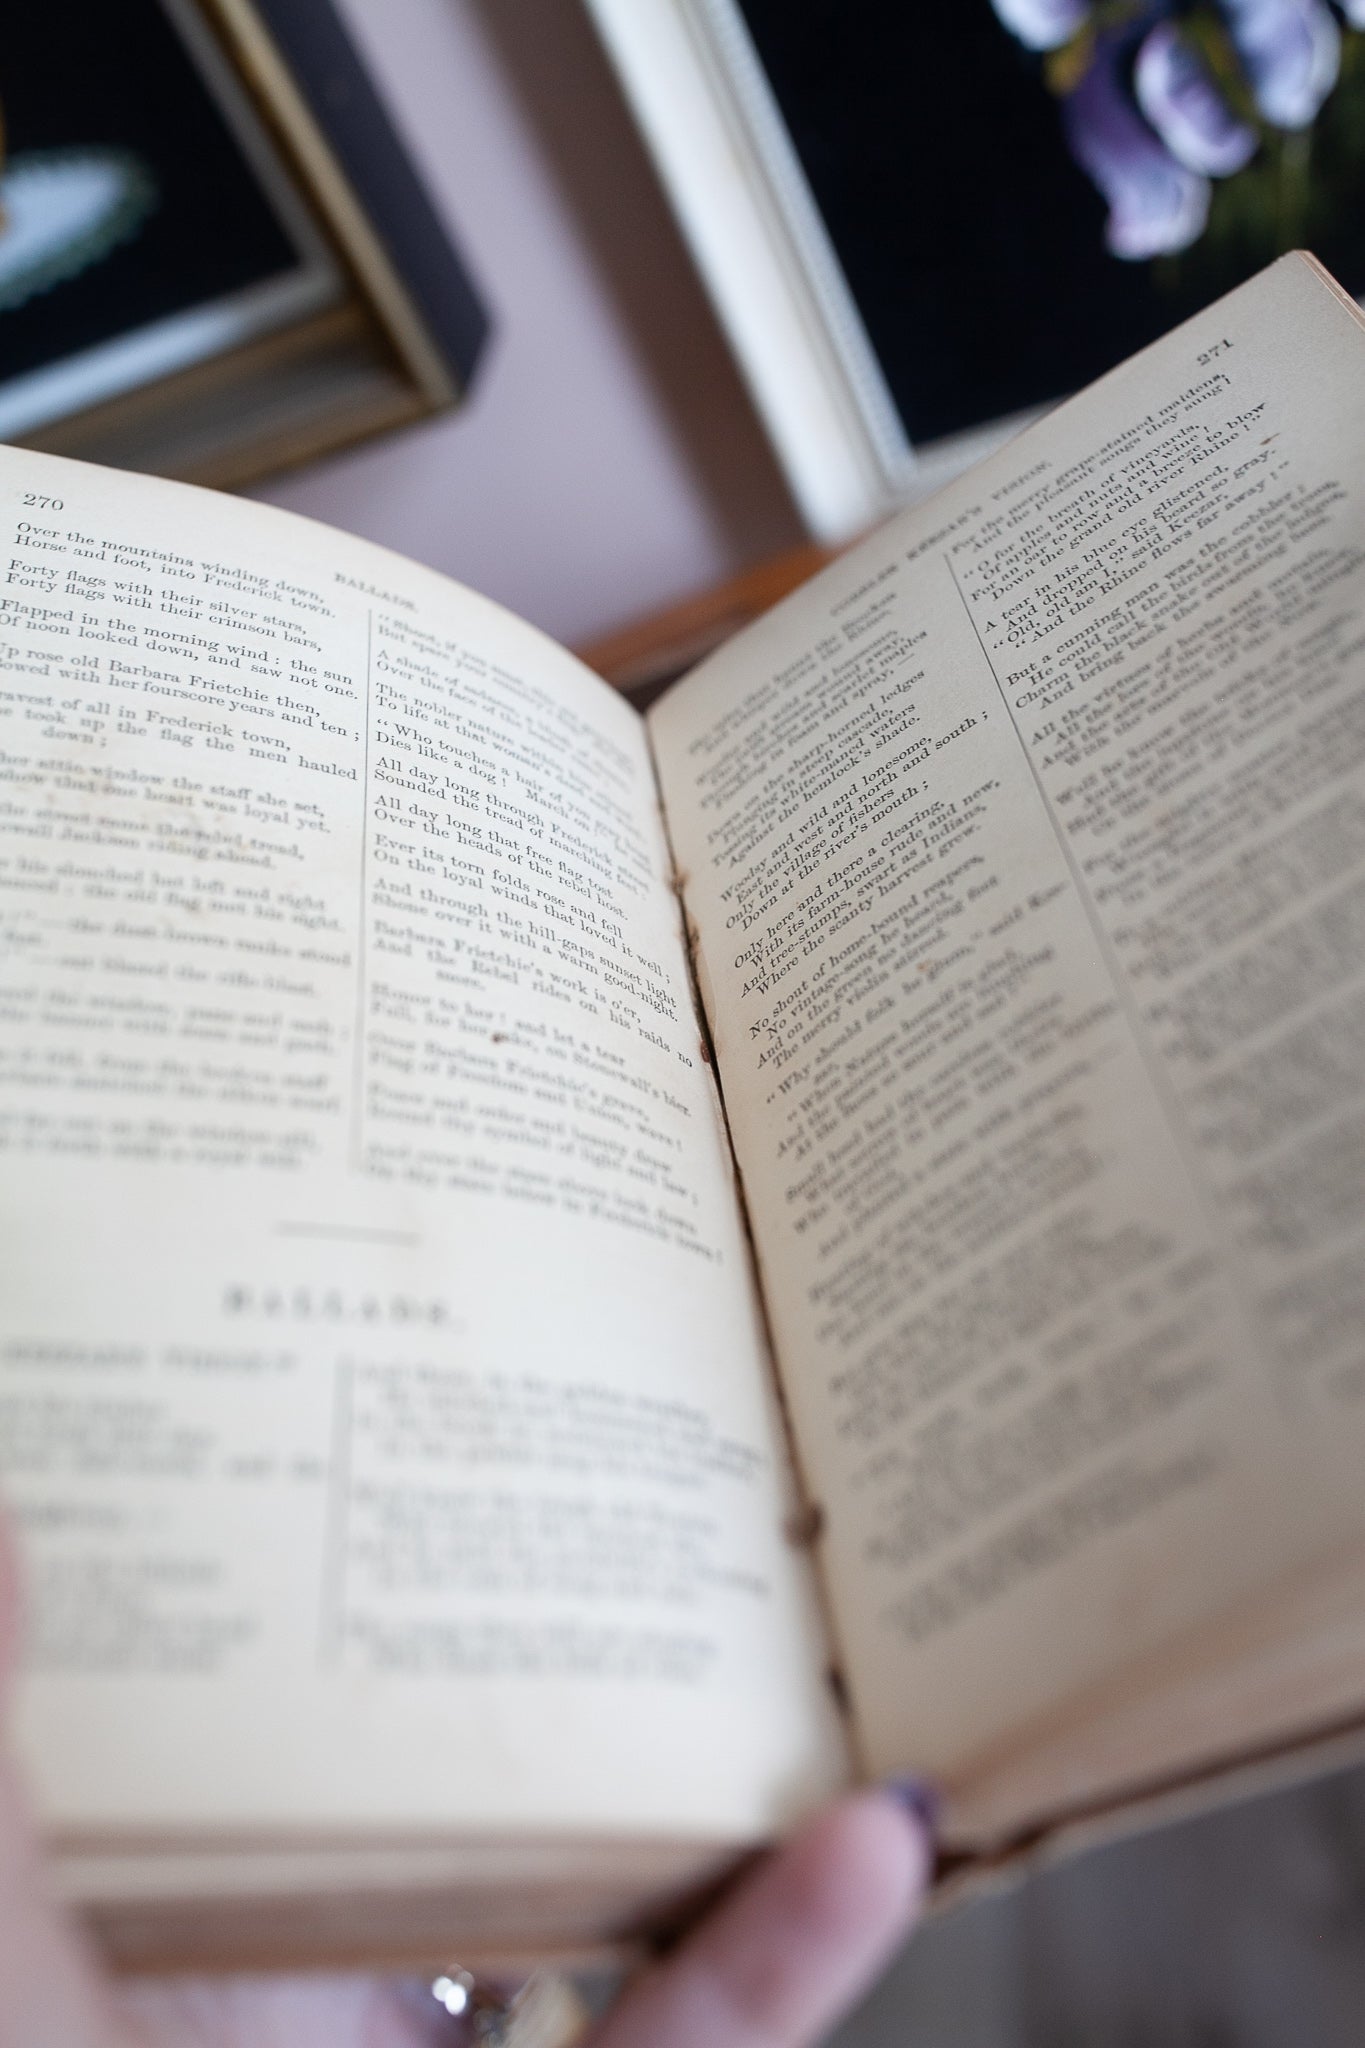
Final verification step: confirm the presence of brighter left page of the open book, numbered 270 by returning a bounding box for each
[0,453,841,1839]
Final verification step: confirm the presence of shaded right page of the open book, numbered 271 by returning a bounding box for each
[651,258,1365,1843]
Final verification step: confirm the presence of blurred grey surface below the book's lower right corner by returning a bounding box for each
[831,1769,1365,2048]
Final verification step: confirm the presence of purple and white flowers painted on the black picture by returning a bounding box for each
[990,0,1365,260]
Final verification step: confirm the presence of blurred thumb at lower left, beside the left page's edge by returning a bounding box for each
[0,1518,127,2048]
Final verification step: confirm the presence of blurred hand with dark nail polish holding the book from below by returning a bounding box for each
[0,1530,931,2048]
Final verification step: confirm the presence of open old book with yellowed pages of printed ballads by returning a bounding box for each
[0,258,1365,1964]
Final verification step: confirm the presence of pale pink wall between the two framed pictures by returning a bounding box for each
[258,0,800,641]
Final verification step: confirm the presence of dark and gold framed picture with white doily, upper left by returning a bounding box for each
[0,0,489,487]
